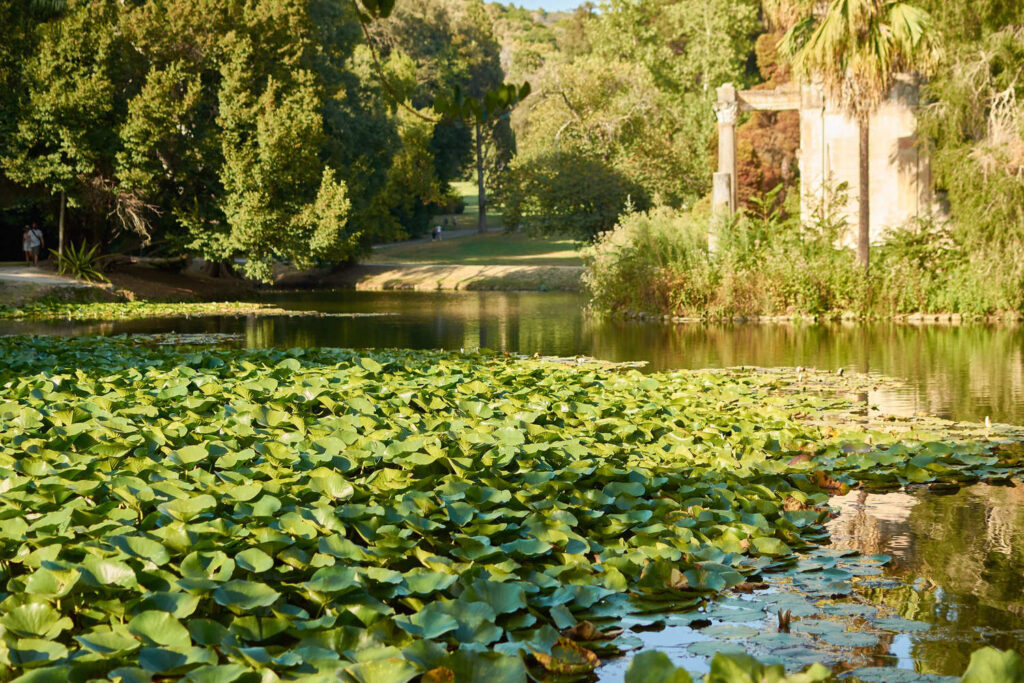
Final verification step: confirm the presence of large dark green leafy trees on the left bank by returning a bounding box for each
[0,0,395,280]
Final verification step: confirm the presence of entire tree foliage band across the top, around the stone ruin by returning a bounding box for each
[0,0,1024,280]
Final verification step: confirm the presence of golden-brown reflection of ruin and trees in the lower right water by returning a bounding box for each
[829,484,1024,675]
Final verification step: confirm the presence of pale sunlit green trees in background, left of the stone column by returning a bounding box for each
[495,0,759,219]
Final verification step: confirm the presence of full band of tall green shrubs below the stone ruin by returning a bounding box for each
[583,194,1024,317]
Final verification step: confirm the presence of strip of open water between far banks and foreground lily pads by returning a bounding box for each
[0,292,1024,424]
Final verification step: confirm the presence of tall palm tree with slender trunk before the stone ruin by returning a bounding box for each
[779,0,937,270]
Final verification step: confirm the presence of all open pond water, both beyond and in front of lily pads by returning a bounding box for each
[0,292,1024,681]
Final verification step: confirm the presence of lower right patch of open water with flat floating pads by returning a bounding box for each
[600,484,1024,683]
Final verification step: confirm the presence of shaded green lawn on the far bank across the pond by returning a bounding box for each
[367,231,583,265]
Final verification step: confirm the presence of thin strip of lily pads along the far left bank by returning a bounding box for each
[0,301,391,321]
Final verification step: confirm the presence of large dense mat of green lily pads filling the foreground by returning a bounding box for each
[0,338,1021,683]
